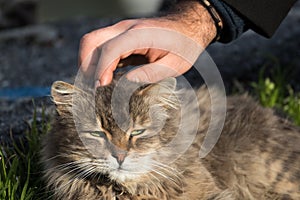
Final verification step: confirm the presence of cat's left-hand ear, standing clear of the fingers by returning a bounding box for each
[51,81,74,114]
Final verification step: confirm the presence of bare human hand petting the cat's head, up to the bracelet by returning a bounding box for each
[79,1,216,85]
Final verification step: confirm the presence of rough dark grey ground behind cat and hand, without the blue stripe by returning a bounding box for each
[0,2,300,141]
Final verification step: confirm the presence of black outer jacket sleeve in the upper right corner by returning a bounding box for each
[223,0,297,37]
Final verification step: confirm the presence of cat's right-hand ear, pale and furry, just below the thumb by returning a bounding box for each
[141,77,178,108]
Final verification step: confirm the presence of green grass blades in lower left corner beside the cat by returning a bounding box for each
[0,105,49,200]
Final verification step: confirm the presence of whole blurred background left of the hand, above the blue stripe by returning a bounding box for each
[0,0,172,89]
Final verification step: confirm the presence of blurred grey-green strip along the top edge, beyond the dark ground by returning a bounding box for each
[0,0,166,28]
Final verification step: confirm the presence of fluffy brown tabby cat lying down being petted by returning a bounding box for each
[41,75,300,200]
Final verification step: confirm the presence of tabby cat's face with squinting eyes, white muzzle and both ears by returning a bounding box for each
[52,76,179,182]
